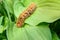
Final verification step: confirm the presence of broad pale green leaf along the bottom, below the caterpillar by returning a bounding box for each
[7,23,52,40]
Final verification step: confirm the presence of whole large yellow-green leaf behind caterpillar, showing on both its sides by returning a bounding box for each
[14,0,60,25]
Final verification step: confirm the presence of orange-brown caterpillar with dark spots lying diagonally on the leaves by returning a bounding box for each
[16,3,36,27]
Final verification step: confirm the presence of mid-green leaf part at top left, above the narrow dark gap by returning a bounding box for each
[3,0,14,13]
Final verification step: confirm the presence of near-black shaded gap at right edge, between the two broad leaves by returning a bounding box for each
[50,19,60,37]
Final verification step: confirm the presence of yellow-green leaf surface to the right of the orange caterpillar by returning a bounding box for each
[25,0,60,25]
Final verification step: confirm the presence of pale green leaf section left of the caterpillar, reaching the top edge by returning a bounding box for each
[13,0,25,18]
